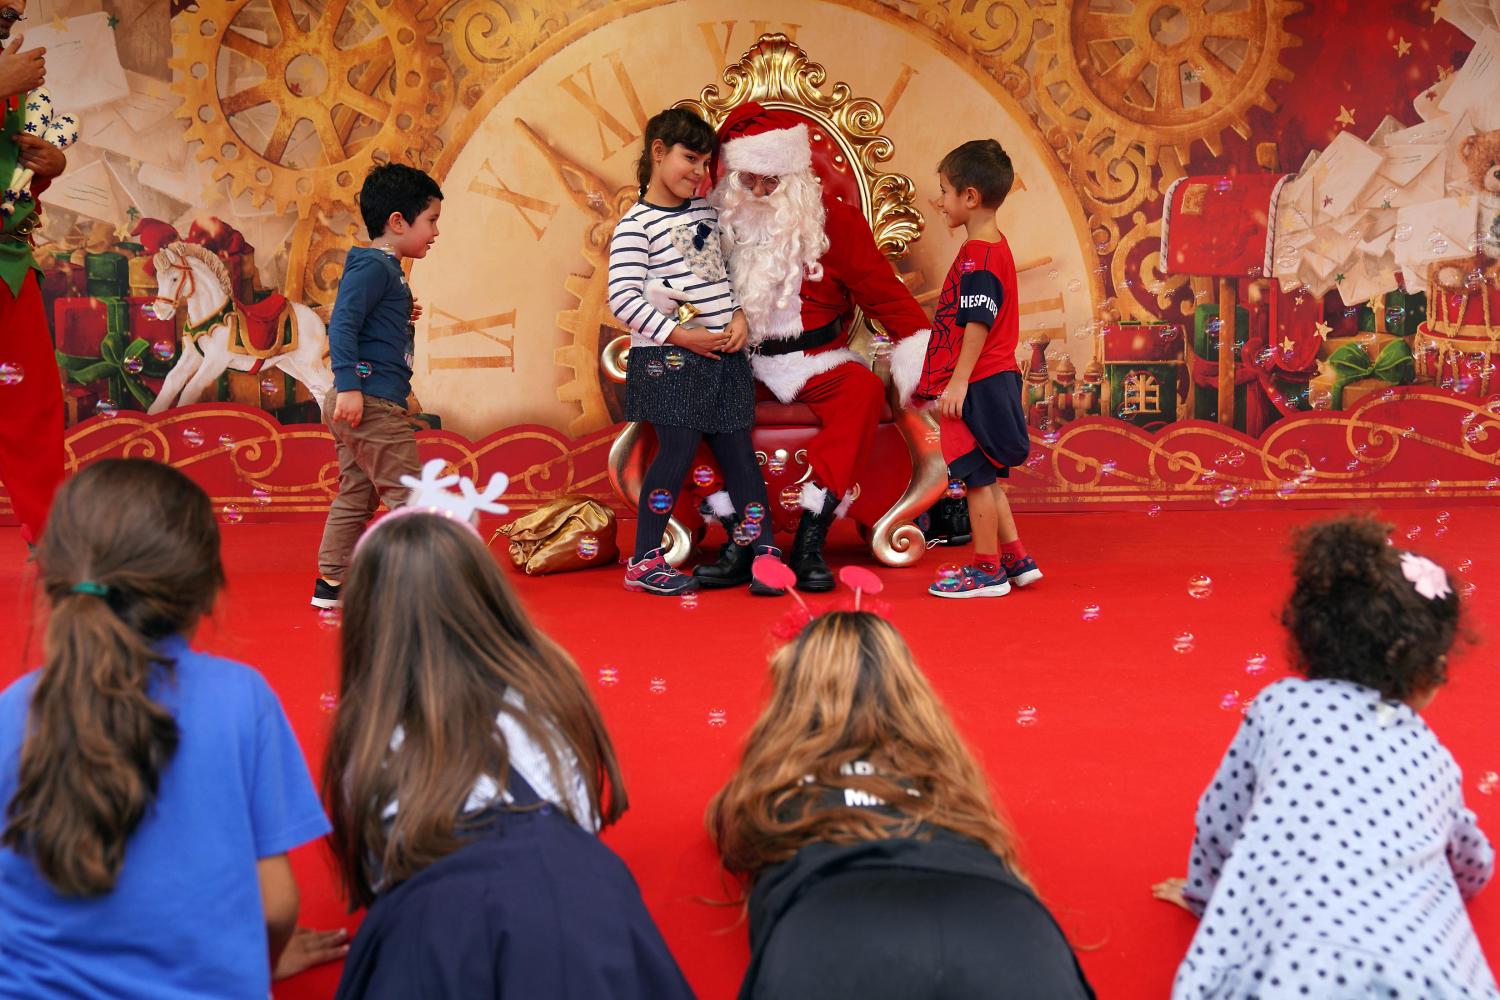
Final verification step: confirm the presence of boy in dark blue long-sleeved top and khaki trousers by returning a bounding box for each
[312,163,443,607]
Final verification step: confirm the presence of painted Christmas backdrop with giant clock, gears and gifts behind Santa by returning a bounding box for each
[0,0,1500,516]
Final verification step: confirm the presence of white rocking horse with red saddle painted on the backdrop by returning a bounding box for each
[147,243,333,414]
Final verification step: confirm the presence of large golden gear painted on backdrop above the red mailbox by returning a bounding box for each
[1037,0,1302,163]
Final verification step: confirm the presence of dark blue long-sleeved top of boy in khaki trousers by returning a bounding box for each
[329,246,416,406]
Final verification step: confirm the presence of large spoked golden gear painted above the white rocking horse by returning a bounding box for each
[170,0,453,217]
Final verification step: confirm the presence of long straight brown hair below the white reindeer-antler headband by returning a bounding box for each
[323,514,627,906]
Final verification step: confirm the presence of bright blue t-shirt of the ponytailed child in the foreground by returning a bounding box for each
[0,637,329,1000]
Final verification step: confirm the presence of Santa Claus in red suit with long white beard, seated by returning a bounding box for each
[701,102,929,591]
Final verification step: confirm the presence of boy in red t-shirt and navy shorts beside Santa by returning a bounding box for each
[915,139,1041,598]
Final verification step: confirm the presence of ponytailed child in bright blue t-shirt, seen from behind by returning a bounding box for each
[0,459,329,1000]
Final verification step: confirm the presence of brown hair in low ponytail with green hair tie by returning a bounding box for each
[0,459,224,897]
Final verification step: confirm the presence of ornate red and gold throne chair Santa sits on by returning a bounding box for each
[603,34,948,567]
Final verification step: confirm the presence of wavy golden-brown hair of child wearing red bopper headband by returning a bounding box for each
[708,612,1025,879]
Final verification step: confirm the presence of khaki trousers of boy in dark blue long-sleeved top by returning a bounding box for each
[318,388,422,582]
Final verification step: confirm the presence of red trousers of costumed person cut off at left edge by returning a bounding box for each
[0,271,65,544]
